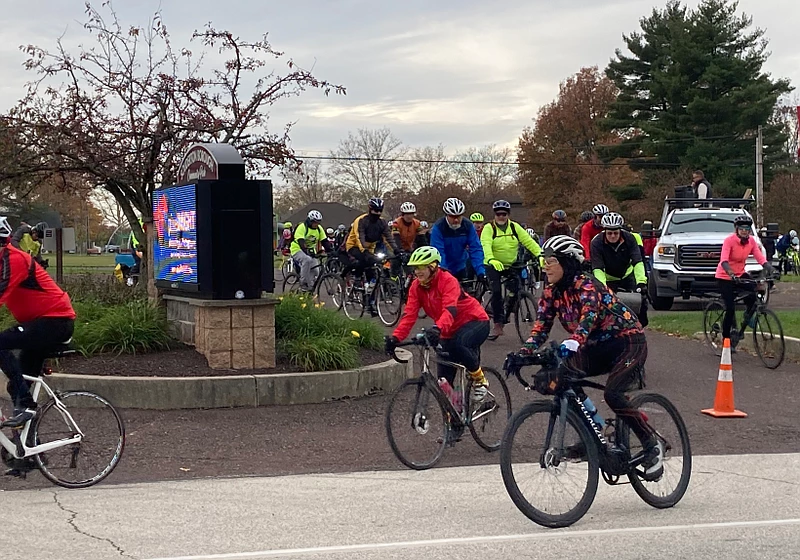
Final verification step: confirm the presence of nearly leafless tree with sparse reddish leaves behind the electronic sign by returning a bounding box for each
[0,1,345,286]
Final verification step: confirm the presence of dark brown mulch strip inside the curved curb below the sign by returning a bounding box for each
[53,346,389,377]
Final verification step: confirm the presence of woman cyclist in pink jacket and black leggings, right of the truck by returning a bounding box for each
[714,215,774,348]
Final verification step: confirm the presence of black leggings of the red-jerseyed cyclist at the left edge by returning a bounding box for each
[0,317,75,408]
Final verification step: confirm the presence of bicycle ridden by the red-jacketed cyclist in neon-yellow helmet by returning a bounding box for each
[385,329,511,470]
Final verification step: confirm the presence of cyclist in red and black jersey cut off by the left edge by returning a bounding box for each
[0,216,75,428]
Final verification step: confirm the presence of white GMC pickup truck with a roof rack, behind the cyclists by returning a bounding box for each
[648,198,764,310]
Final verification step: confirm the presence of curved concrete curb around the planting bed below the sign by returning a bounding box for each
[0,349,415,410]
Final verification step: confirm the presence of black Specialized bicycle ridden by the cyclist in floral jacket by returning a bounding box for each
[500,343,692,528]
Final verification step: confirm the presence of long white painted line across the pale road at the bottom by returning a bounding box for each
[146,518,800,560]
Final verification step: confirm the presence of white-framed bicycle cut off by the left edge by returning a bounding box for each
[0,347,125,488]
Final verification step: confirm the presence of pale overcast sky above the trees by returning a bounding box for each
[0,0,800,158]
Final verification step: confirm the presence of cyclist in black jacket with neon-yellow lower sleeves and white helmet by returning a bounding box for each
[592,212,648,327]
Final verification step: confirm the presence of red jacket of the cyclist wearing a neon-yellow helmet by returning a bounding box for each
[392,269,489,340]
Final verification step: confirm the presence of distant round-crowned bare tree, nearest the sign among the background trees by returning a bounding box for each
[331,127,405,199]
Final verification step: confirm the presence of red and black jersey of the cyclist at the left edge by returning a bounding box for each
[0,246,75,323]
